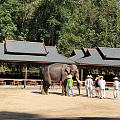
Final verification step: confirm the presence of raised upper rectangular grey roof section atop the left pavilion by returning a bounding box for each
[5,40,47,55]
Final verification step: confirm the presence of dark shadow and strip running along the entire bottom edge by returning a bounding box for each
[0,111,120,120]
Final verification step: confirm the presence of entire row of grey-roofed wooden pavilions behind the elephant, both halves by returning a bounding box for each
[0,40,120,87]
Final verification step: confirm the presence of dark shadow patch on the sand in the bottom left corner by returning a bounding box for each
[0,111,44,119]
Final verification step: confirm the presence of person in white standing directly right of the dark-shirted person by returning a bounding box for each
[99,76,106,99]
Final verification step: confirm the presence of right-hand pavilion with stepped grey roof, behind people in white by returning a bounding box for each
[70,47,120,81]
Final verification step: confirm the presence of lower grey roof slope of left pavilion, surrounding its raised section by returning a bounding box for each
[0,43,75,64]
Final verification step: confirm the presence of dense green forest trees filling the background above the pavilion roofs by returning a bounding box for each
[0,0,120,56]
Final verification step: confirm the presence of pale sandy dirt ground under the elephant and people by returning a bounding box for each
[0,87,120,119]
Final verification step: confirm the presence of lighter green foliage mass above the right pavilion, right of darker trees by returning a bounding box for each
[58,0,120,55]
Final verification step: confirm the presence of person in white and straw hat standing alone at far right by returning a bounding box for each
[113,77,120,99]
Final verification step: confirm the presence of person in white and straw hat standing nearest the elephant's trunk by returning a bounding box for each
[85,75,93,97]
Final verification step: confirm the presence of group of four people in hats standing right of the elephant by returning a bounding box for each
[85,75,120,99]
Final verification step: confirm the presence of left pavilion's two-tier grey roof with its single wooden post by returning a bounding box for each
[0,40,75,88]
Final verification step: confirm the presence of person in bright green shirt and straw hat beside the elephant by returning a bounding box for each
[67,74,74,96]
